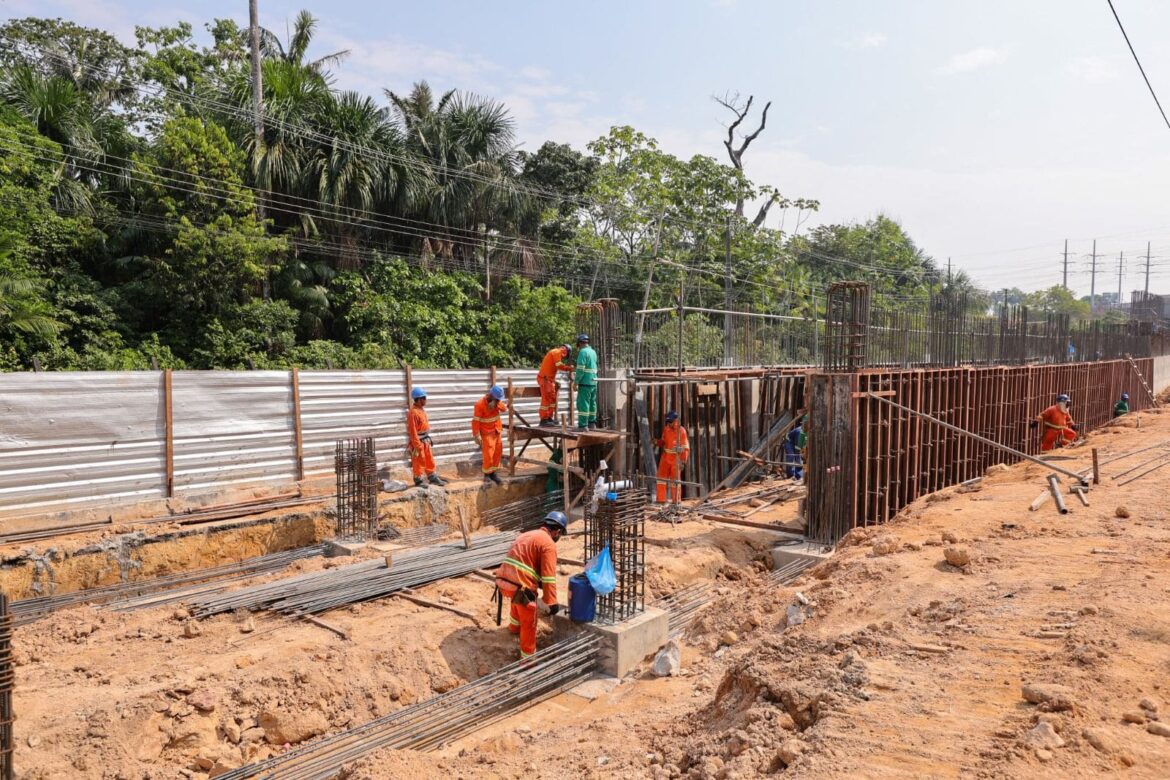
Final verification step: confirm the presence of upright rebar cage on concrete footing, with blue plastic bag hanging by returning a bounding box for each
[585,485,646,623]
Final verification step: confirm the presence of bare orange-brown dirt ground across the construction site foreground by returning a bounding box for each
[15,413,1170,780]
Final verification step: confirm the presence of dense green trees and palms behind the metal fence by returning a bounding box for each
[0,13,986,370]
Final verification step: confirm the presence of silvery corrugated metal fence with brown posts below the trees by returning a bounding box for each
[0,368,540,516]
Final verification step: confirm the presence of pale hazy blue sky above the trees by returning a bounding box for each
[0,0,1170,298]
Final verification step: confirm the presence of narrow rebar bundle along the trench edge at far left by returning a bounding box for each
[12,545,325,626]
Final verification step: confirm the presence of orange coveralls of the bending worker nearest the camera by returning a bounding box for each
[496,527,557,658]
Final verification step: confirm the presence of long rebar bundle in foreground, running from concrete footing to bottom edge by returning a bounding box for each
[219,634,599,780]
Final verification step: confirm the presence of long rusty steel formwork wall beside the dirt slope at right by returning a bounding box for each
[828,358,1154,541]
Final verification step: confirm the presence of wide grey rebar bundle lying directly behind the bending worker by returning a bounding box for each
[187,532,516,617]
